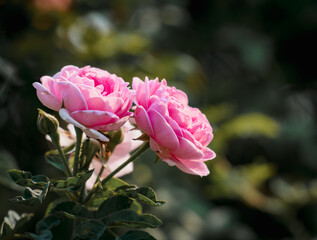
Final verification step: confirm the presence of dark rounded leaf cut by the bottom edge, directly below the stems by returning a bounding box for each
[75,219,106,240]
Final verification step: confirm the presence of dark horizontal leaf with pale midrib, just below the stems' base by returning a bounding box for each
[50,202,92,219]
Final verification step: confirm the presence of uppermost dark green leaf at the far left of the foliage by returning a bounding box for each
[8,169,49,189]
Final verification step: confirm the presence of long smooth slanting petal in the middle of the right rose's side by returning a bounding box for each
[148,109,179,151]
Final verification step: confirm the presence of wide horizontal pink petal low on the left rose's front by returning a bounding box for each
[70,110,119,127]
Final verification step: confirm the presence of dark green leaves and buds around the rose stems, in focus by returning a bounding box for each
[0,110,164,240]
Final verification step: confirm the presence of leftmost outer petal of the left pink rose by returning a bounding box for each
[33,82,62,111]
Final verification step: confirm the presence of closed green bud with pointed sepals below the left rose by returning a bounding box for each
[37,109,59,144]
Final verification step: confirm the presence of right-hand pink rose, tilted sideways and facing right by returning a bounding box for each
[132,78,216,176]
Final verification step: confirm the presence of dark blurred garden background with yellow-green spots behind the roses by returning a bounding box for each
[0,0,317,240]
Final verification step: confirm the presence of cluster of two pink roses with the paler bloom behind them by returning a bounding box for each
[33,66,215,177]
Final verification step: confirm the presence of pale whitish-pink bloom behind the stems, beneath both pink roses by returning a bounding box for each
[46,122,142,190]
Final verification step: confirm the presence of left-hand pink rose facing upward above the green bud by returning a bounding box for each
[33,66,133,142]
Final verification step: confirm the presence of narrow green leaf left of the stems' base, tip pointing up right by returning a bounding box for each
[53,169,94,189]
